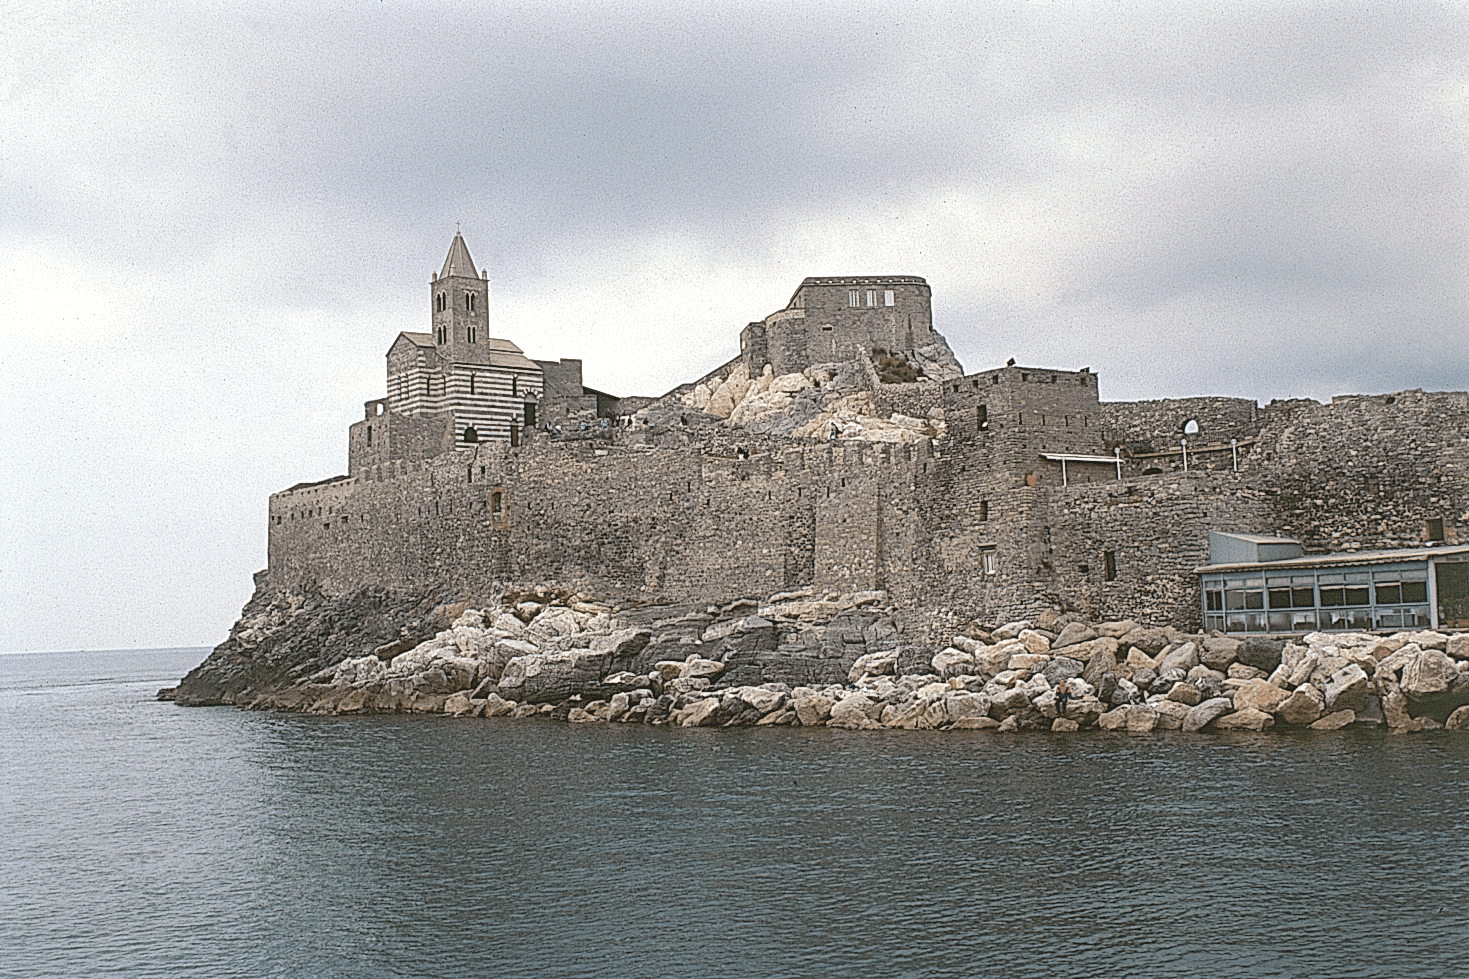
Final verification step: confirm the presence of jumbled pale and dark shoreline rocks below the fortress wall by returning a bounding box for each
[160,584,1469,732]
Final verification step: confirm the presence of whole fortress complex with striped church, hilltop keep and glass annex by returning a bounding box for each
[269,235,1469,634]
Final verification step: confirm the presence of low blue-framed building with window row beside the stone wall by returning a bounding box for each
[1196,531,1469,634]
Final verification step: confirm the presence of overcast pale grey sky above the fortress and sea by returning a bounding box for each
[0,0,1469,651]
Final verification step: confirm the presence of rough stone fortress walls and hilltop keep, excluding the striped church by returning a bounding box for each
[269,248,1469,629]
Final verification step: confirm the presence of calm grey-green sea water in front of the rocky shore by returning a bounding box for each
[0,650,1469,979]
